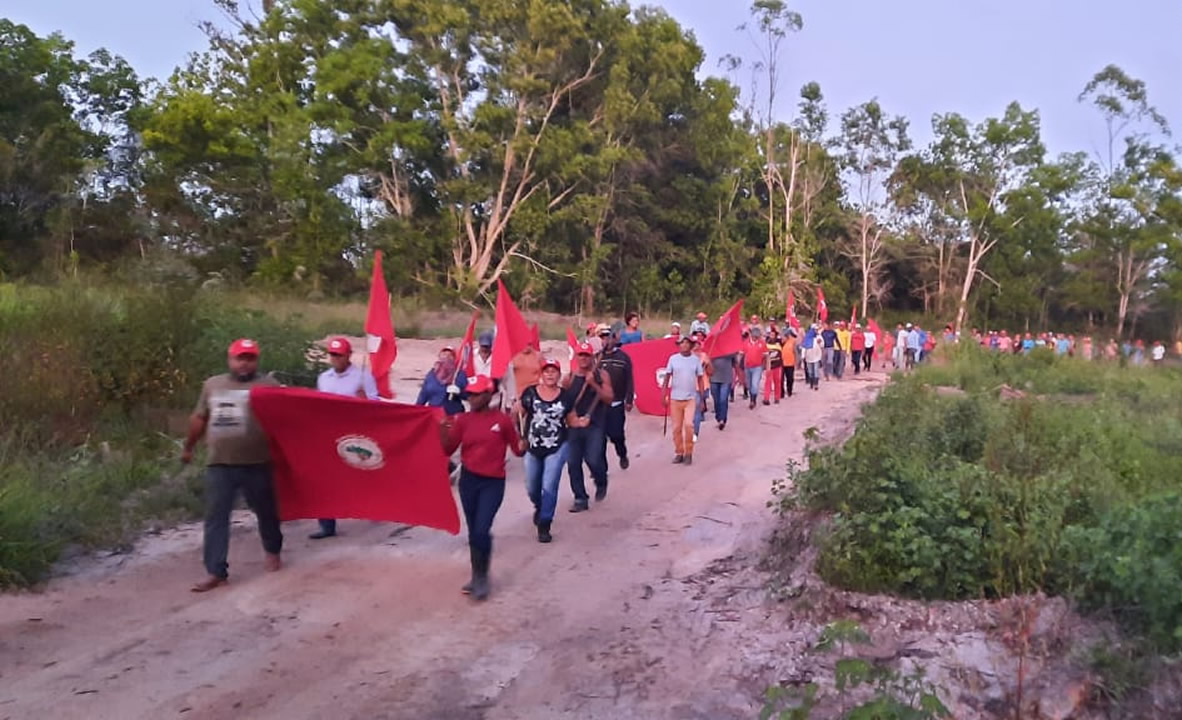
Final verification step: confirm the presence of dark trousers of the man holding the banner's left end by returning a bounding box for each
[203,465,284,578]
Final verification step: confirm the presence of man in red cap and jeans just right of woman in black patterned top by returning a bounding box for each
[566,343,615,512]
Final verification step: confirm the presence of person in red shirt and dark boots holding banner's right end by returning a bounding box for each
[440,375,526,601]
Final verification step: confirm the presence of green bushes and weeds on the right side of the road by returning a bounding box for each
[785,346,1182,648]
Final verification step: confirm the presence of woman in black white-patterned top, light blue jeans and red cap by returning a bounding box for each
[518,358,574,543]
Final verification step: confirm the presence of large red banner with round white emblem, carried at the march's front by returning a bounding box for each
[251,385,460,534]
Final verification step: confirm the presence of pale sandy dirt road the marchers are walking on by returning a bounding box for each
[0,344,883,720]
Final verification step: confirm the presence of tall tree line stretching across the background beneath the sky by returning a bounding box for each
[0,0,1182,337]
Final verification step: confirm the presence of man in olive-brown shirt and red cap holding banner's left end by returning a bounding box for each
[181,338,284,592]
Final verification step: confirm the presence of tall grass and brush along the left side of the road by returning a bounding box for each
[0,285,313,586]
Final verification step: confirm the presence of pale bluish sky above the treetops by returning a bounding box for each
[9,0,1182,153]
